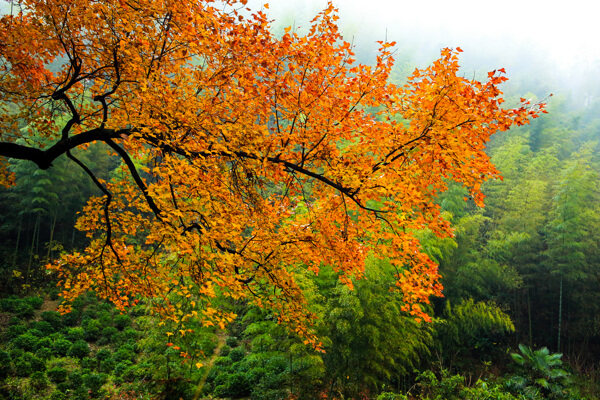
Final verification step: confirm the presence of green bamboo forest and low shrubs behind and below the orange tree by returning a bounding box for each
[0,6,600,400]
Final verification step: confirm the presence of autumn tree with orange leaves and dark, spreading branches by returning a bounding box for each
[0,0,543,340]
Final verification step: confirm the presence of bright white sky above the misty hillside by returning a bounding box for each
[250,0,600,73]
